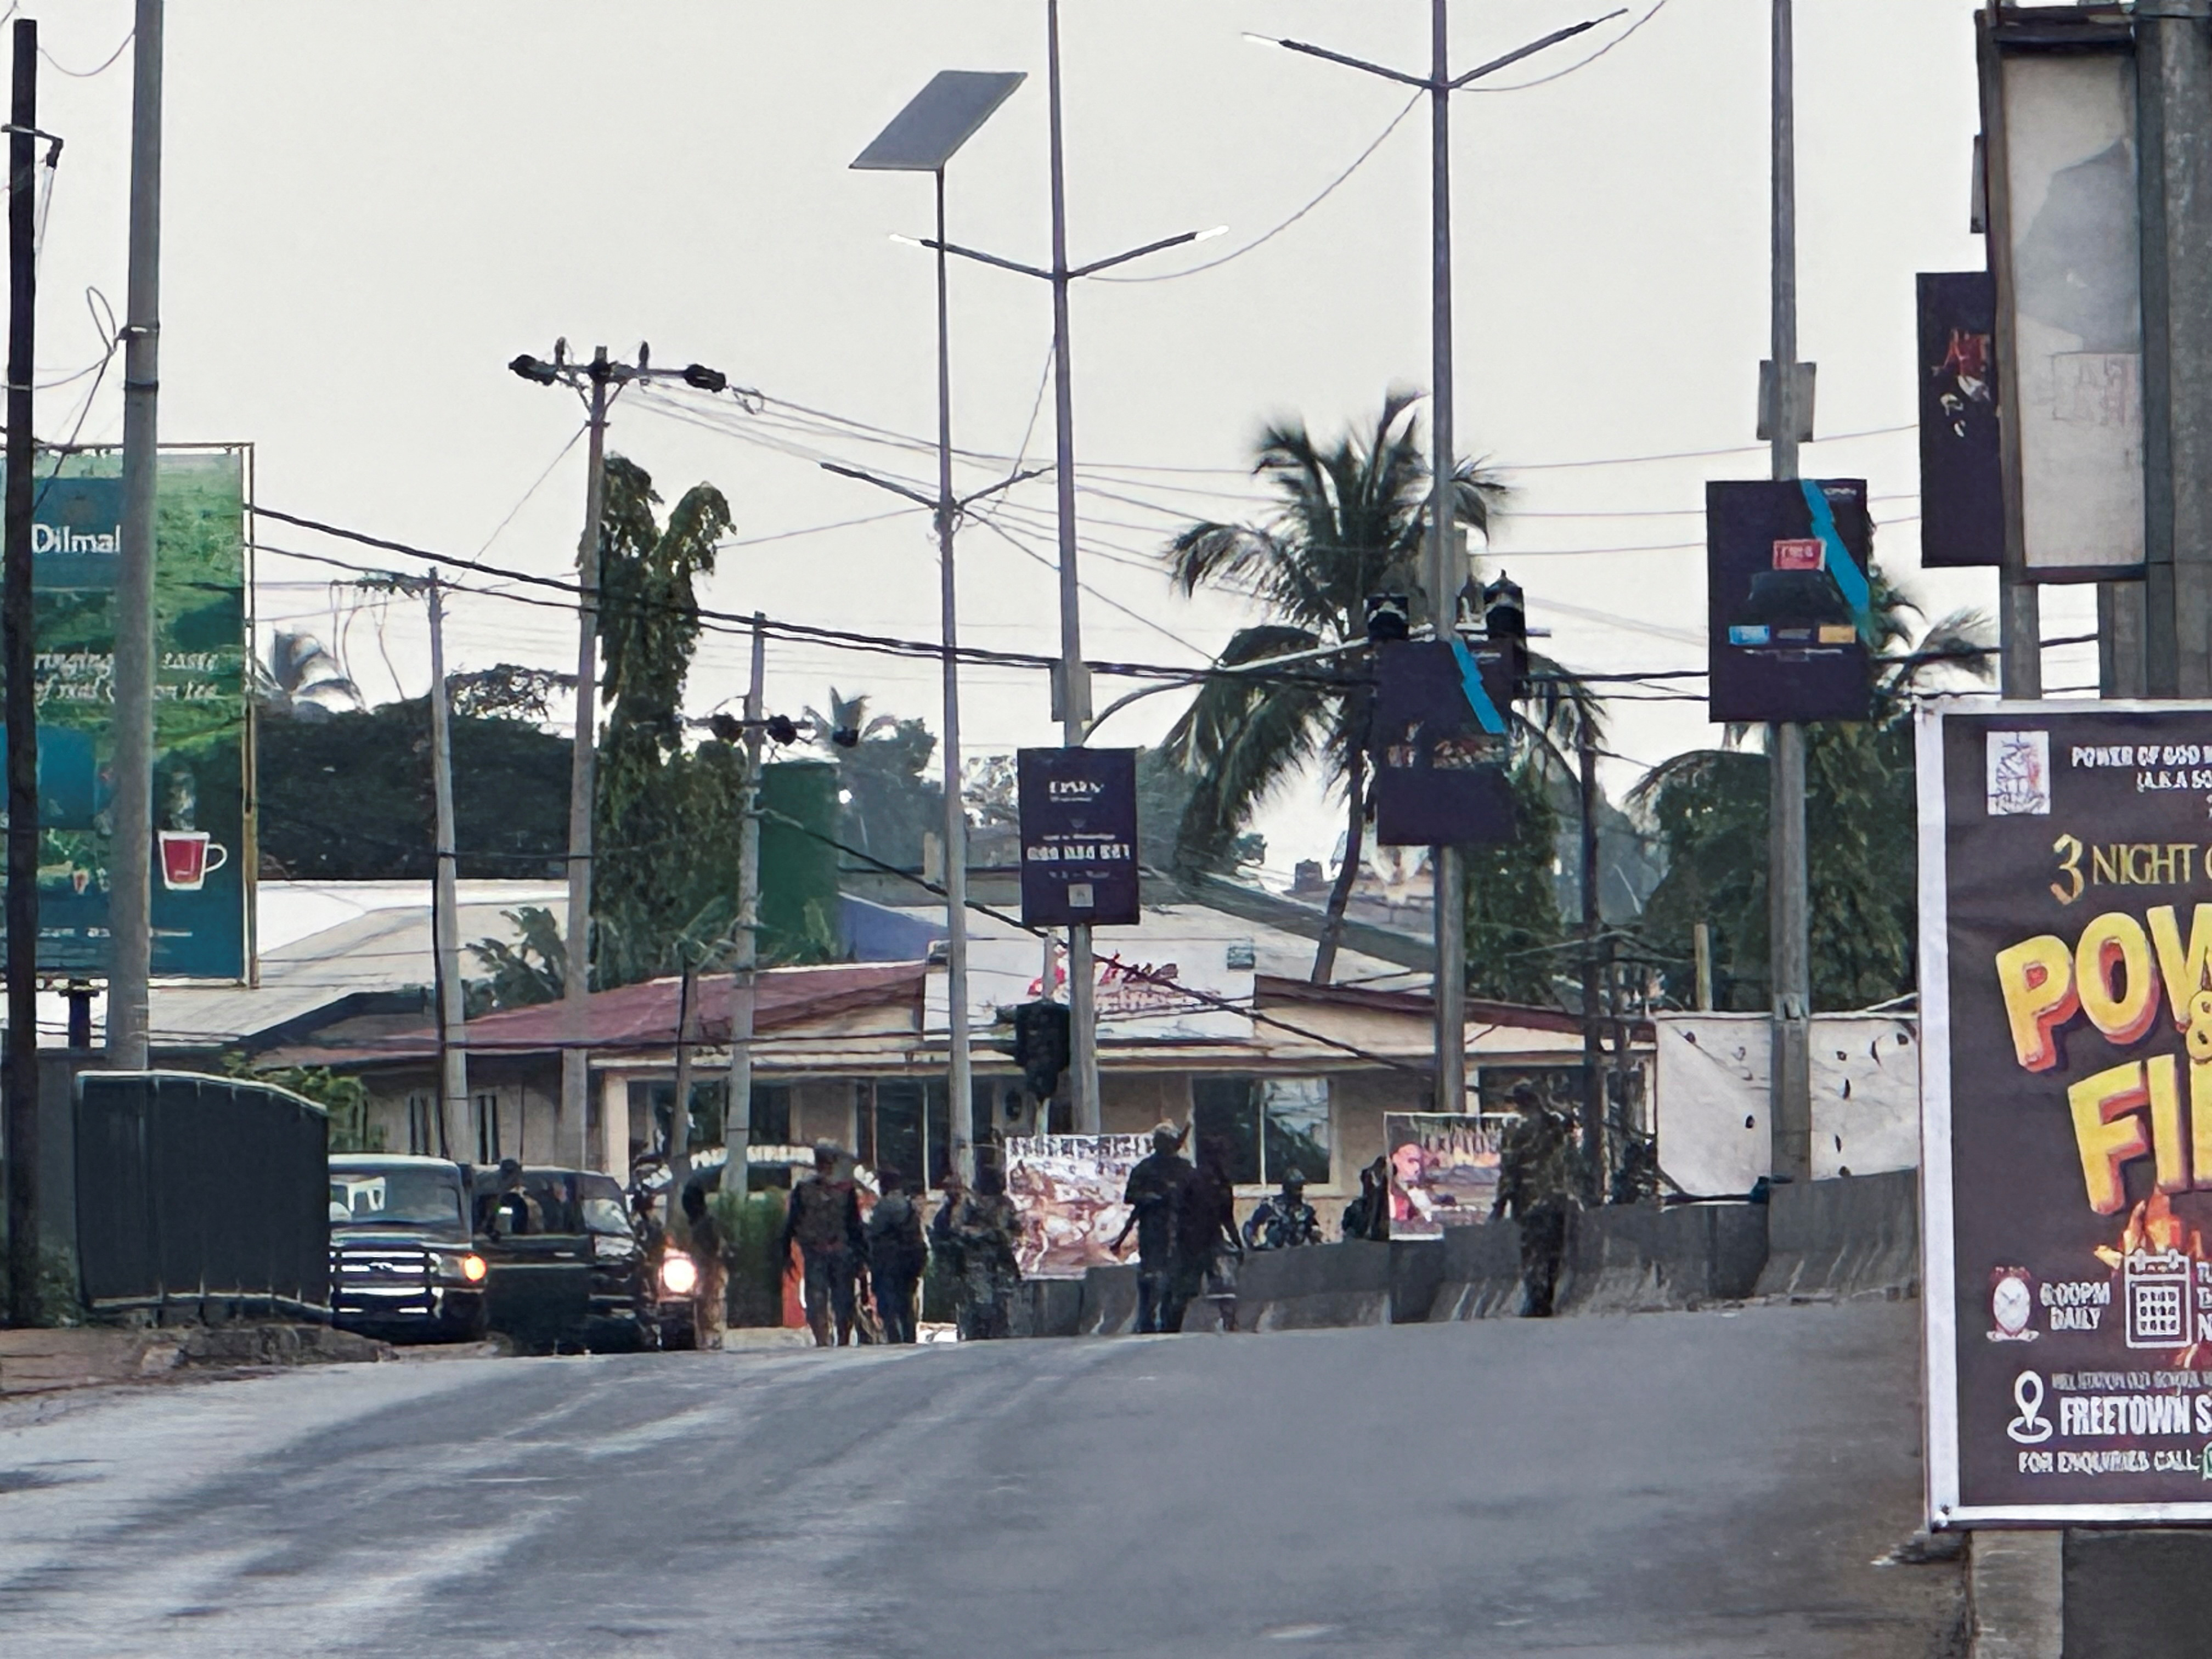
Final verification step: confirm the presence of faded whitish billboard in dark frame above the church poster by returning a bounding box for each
[1982,24,2143,582]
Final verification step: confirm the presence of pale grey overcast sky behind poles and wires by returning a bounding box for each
[20,0,2095,872]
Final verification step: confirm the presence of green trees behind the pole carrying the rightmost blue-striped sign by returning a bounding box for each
[1630,568,1991,1009]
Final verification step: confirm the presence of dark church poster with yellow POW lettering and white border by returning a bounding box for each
[1918,703,2212,1524]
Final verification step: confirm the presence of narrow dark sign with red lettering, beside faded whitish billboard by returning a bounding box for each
[1920,270,2004,568]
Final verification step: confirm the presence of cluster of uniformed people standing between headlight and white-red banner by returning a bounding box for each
[776,1142,1022,1347]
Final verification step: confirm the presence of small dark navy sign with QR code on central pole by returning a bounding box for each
[1018,750,1137,927]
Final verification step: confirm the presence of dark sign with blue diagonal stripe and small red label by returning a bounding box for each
[1706,478,1874,721]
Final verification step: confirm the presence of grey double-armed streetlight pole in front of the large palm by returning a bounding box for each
[1248,0,1621,1113]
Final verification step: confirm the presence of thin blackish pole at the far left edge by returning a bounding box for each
[0,18,40,1325]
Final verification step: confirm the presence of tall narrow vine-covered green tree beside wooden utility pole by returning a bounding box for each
[591,456,746,989]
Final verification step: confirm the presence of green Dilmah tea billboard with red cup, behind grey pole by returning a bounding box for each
[5,449,255,980]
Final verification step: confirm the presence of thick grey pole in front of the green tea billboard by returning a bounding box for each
[106,0,161,1070]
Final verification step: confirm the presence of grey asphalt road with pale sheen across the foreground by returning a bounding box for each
[0,1305,1960,1659]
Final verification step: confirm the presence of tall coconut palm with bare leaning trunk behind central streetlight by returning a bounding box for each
[1164,392,1506,984]
